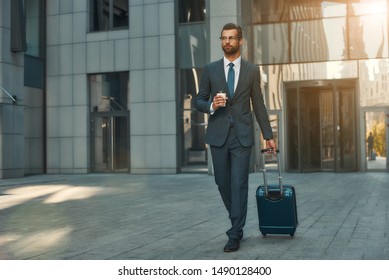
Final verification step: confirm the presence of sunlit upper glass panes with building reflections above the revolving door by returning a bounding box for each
[253,0,389,64]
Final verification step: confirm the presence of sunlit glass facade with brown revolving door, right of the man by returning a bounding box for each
[252,0,389,172]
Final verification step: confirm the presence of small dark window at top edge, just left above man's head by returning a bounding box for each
[178,0,206,23]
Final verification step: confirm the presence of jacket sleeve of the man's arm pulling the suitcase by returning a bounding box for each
[251,65,273,140]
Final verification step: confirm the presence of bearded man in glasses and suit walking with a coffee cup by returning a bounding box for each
[196,23,276,252]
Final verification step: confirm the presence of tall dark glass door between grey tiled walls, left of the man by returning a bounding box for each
[89,72,130,172]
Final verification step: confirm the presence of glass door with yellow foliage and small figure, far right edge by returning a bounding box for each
[364,109,389,171]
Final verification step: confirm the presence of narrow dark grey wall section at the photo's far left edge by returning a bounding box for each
[0,0,24,178]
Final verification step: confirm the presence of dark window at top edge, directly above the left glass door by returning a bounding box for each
[90,0,128,31]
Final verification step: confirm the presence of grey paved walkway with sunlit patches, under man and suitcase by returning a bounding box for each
[0,172,389,260]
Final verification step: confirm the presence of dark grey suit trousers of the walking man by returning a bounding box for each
[211,127,252,240]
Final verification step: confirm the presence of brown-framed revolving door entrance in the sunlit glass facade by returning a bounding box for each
[286,81,357,172]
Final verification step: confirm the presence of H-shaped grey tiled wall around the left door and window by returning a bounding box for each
[46,0,177,173]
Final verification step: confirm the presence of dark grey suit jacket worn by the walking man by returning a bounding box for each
[196,59,273,147]
